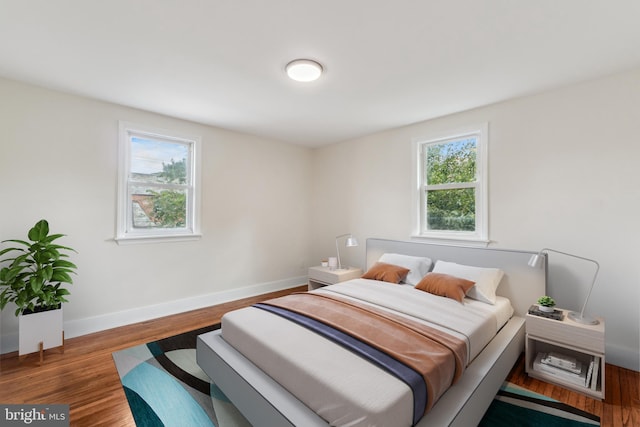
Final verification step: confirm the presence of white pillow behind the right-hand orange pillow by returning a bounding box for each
[433,260,504,305]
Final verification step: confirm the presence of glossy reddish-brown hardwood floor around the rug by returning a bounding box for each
[0,288,640,427]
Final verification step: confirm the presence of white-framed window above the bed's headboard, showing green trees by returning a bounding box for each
[414,124,488,241]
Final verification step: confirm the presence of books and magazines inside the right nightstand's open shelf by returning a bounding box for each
[533,352,600,390]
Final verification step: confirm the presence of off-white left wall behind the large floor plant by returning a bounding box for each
[0,79,312,352]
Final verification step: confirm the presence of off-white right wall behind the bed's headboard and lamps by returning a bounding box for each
[311,69,640,370]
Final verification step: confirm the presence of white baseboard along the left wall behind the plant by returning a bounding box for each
[0,276,307,354]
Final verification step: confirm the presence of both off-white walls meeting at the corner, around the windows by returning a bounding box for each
[0,70,640,370]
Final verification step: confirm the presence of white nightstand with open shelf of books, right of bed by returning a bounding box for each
[525,310,605,400]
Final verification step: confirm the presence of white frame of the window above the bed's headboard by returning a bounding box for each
[412,123,489,246]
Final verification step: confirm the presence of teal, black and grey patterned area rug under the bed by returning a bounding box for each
[113,325,600,427]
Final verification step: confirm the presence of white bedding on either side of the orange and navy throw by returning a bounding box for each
[222,279,513,426]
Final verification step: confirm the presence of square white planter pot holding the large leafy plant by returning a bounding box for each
[18,307,63,356]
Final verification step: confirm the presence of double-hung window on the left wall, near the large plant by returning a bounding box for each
[116,122,200,243]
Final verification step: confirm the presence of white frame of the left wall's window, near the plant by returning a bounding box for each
[115,121,201,244]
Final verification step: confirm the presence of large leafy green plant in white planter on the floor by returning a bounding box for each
[0,219,77,355]
